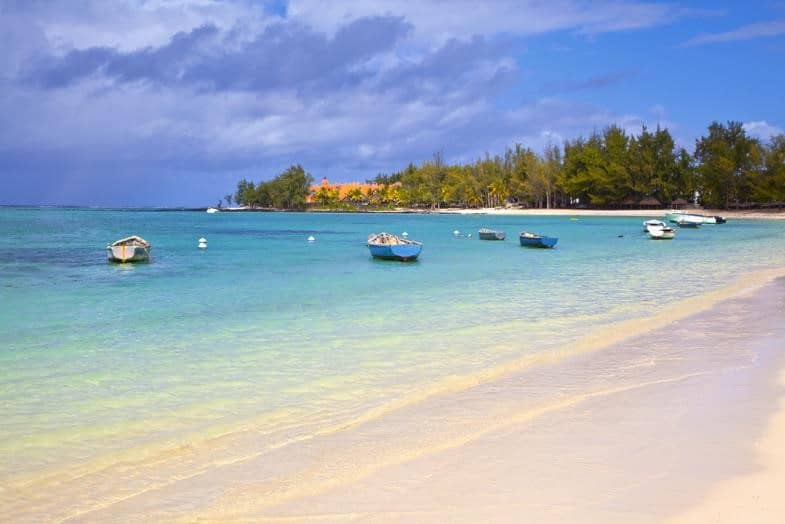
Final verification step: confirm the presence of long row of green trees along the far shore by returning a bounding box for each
[235,121,785,209]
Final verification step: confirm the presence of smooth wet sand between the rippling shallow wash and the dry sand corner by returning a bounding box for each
[172,279,785,523]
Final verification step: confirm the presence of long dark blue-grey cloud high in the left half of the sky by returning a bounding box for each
[25,16,410,91]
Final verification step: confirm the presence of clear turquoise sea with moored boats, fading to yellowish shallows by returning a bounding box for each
[0,208,785,479]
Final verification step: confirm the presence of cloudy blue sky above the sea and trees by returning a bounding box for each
[0,0,785,206]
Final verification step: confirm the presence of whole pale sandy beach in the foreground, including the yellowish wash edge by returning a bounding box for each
[7,272,785,523]
